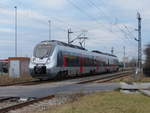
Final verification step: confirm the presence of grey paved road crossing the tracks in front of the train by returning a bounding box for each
[0,83,120,98]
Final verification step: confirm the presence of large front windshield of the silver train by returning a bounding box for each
[34,45,52,58]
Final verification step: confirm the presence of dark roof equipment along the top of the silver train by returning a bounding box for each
[41,40,117,57]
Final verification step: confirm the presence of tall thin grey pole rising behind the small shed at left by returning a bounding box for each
[14,6,17,57]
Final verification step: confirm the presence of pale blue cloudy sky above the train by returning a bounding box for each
[0,0,150,60]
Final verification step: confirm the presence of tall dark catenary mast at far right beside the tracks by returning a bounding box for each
[137,12,142,72]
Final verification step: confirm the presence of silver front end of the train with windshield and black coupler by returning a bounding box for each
[29,41,56,80]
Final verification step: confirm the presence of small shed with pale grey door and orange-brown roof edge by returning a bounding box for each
[8,57,30,77]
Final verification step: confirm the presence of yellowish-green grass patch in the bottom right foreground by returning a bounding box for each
[42,91,150,113]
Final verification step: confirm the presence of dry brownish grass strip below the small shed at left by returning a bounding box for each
[0,74,34,85]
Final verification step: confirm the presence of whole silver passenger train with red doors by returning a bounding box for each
[29,41,118,79]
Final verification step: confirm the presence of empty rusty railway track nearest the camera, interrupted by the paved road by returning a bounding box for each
[0,71,132,113]
